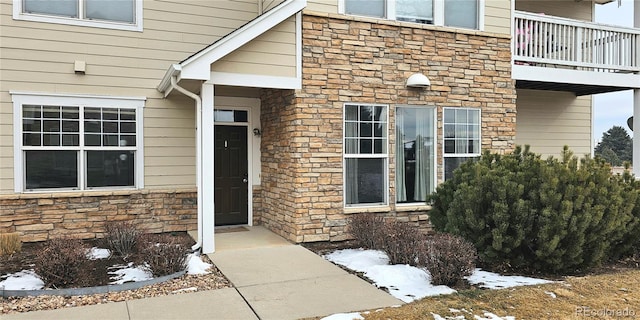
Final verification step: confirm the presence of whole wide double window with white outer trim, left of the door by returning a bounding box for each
[12,93,144,192]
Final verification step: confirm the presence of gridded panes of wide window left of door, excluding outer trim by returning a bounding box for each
[22,105,137,190]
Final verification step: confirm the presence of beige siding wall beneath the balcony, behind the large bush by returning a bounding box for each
[516,89,592,157]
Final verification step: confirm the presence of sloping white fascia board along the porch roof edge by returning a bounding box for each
[181,0,307,81]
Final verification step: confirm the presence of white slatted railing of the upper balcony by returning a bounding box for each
[512,11,640,73]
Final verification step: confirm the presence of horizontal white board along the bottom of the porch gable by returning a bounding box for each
[209,72,302,89]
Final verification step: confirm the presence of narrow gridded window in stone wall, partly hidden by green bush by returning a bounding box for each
[443,108,481,180]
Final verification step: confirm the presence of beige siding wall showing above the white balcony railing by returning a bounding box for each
[516,0,594,21]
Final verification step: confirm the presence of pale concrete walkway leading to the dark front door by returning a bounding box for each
[0,227,402,320]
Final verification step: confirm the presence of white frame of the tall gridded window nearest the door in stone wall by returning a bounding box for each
[342,102,388,209]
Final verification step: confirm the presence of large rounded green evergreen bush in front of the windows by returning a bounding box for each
[430,147,640,272]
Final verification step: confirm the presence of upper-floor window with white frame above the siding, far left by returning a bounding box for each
[13,0,142,31]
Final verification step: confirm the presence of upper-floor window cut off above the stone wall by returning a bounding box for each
[343,0,483,29]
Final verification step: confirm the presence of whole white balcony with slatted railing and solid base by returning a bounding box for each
[512,11,640,95]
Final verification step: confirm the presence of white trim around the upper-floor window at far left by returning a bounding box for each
[13,0,143,32]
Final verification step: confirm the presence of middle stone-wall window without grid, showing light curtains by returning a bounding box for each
[395,107,436,203]
